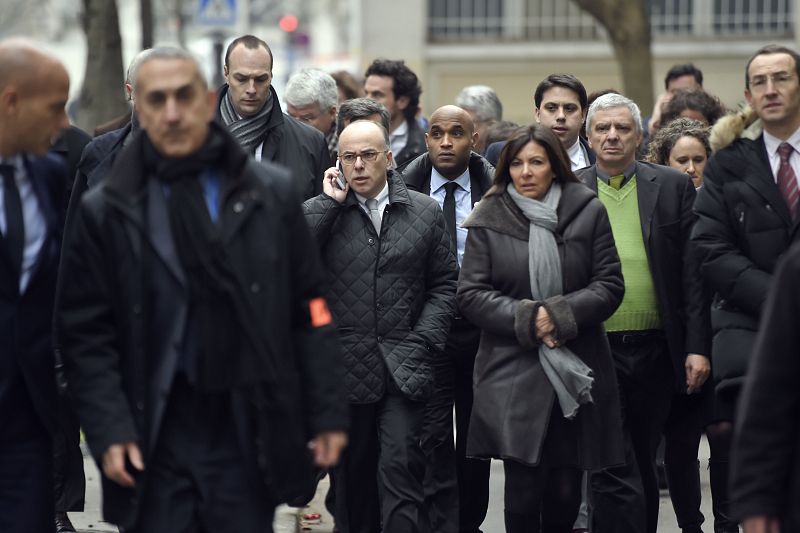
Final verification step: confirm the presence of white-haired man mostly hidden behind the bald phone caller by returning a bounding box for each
[283,68,339,160]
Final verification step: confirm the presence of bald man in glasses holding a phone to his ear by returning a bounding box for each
[303,120,457,533]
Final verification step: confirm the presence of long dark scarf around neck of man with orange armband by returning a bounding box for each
[143,124,276,392]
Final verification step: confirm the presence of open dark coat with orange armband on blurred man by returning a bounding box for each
[58,129,347,528]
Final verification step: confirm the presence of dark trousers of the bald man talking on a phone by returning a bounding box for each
[332,386,428,533]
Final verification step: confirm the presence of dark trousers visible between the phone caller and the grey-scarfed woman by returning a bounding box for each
[422,317,490,533]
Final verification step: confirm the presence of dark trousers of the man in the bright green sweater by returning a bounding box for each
[591,334,674,533]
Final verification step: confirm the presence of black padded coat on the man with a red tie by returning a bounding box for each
[692,137,800,392]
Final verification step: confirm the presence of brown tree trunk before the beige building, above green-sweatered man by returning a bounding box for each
[572,0,654,114]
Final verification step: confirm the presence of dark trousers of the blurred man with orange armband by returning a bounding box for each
[128,375,275,533]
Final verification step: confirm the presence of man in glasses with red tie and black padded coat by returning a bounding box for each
[692,45,800,531]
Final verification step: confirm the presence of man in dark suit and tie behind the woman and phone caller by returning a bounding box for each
[401,105,494,533]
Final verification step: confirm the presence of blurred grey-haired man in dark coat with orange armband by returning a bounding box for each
[59,48,347,533]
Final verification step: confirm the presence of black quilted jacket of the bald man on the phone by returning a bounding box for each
[303,171,457,403]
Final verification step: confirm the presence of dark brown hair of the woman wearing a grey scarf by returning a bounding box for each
[486,124,579,196]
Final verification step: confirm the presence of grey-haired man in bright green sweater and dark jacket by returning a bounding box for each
[576,94,710,533]
